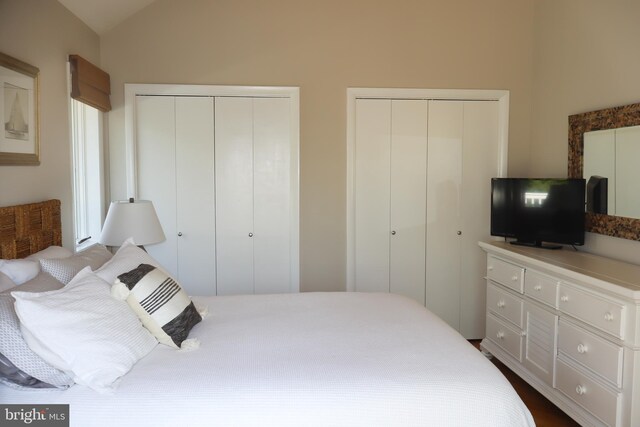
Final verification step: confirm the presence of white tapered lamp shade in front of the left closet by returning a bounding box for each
[100,199,165,246]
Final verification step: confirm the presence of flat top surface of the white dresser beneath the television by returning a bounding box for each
[479,241,640,299]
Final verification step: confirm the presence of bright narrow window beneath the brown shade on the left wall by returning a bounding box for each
[70,99,105,249]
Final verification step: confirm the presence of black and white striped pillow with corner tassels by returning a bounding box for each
[111,264,202,348]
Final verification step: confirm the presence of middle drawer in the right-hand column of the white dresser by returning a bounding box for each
[558,320,623,387]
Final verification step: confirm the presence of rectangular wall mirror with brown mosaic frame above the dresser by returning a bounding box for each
[568,104,640,240]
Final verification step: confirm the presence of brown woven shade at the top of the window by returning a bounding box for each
[69,55,111,112]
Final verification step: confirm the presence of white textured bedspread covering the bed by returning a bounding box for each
[0,293,534,427]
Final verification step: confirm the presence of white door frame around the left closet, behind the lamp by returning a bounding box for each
[124,83,300,292]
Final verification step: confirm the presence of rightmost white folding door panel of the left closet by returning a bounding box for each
[253,98,291,293]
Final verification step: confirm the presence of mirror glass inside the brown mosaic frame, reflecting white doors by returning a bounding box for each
[583,126,640,219]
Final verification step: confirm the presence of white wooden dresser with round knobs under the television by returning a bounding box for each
[480,242,640,426]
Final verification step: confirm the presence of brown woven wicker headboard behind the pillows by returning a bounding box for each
[0,200,62,259]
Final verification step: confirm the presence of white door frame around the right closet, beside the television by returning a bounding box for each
[346,88,509,292]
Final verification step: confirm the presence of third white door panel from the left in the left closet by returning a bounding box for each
[215,97,254,295]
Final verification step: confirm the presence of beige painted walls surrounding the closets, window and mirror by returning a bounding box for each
[0,0,640,290]
